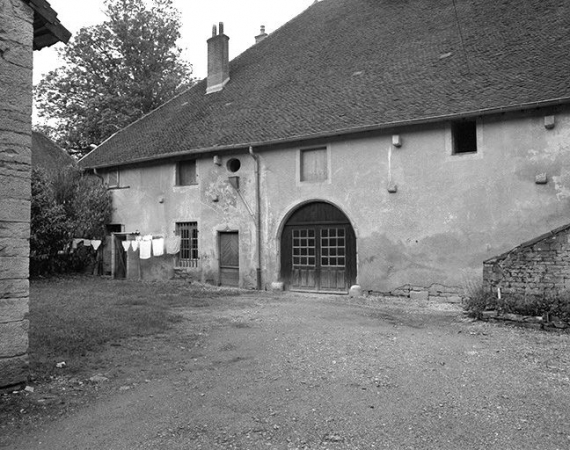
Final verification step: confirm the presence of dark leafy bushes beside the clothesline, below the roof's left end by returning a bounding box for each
[30,166,112,275]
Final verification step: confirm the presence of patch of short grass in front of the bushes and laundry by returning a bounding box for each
[29,277,239,379]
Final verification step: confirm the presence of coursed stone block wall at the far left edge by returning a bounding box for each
[0,0,33,388]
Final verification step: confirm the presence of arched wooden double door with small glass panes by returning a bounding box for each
[281,202,356,292]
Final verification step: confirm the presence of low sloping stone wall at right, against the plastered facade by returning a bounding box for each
[483,225,570,296]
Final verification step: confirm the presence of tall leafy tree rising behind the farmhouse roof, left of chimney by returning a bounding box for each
[35,0,193,156]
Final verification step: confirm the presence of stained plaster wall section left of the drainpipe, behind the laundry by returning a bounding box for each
[112,152,257,288]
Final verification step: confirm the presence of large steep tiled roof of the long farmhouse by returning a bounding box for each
[82,0,570,167]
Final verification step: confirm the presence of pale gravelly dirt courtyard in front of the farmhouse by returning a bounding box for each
[1,294,570,450]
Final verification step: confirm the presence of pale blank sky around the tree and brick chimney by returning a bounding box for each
[34,0,314,84]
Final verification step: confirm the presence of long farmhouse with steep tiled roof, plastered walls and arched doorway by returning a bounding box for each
[81,0,570,298]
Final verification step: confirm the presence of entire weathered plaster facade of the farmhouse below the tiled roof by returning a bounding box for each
[105,110,570,293]
